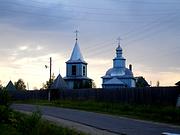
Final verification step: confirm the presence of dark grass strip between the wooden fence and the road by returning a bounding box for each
[17,100,180,125]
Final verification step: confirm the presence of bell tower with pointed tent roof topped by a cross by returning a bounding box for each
[63,31,92,89]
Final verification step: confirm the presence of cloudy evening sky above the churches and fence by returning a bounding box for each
[0,0,180,89]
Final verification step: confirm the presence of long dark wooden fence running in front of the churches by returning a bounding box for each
[0,87,180,105]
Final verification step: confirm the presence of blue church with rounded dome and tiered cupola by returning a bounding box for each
[101,39,135,88]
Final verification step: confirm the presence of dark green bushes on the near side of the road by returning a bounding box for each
[0,90,86,135]
